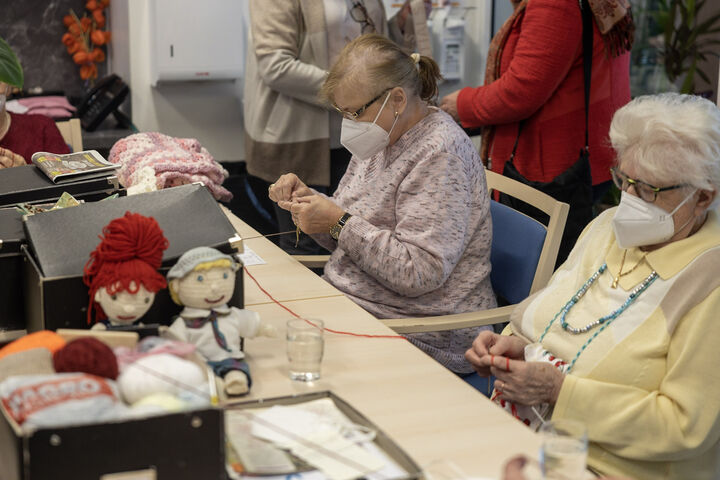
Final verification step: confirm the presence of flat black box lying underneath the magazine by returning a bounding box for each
[0,165,120,207]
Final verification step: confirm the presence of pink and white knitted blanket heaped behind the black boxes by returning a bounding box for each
[109,132,233,201]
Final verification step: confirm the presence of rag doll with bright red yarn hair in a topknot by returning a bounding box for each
[83,212,168,329]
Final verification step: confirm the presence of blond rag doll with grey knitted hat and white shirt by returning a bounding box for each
[167,247,277,395]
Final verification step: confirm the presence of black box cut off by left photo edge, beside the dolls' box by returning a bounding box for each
[0,209,25,338]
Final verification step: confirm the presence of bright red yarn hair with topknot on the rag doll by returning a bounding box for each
[83,212,168,324]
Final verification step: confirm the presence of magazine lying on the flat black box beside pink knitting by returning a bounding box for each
[32,150,120,183]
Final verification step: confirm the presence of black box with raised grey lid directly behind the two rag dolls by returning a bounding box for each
[23,184,243,332]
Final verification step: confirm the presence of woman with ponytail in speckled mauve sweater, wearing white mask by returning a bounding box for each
[270,34,496,374]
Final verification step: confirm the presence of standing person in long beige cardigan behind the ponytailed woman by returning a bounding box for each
[243,0,431,254]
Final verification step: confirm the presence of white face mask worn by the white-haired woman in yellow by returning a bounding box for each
[613,192,695,248]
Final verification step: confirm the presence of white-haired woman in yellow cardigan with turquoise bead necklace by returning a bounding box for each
[466,94,720,479]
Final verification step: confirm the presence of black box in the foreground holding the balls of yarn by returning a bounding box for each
[0,332,226,480]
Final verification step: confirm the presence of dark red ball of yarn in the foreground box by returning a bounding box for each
[53,337,118,380]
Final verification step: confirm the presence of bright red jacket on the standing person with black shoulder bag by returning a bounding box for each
[457,0,630,185]
